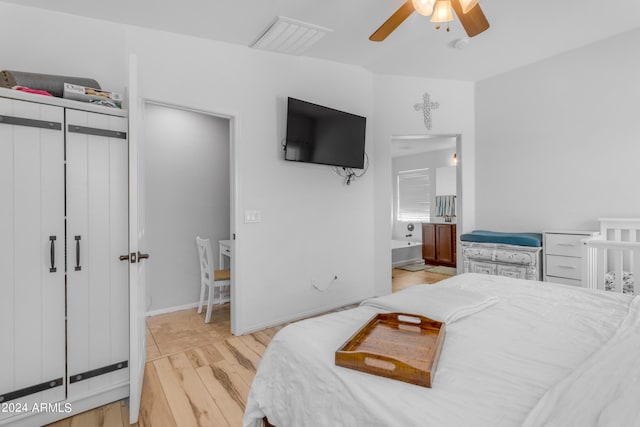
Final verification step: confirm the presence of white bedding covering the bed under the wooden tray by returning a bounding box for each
[244,274,640,427]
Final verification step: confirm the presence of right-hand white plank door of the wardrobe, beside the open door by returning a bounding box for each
[66,109,129,398]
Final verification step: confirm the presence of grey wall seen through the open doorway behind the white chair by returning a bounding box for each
[144,104,231,311]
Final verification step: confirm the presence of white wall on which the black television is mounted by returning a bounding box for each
[122,28,373,332]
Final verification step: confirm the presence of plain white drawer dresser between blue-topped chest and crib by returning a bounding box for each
[543,230,597,286]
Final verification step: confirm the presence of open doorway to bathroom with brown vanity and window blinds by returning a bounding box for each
[391,135,460,292]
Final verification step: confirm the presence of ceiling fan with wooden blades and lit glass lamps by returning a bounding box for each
[369,0,489,42]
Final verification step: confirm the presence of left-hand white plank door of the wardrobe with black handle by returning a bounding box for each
[0,98,65,420]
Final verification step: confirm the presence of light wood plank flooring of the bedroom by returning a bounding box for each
[49,268,449,427]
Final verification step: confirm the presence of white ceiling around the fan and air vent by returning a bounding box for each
[4,0,640,81]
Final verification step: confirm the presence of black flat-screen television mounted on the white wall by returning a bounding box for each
[284,98,367,169]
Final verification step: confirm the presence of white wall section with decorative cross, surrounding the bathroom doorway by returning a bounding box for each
[372,76,475,295]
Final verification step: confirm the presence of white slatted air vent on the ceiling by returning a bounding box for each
[249,16,333,55]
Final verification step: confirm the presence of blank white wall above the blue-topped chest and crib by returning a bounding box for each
[476,30,640,231]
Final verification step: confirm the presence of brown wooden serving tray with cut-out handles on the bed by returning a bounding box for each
[336,313,445,387]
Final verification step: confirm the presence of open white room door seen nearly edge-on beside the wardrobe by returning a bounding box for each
[129,55,148,424]
